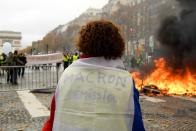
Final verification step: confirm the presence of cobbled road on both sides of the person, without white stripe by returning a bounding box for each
[0,91,196,131]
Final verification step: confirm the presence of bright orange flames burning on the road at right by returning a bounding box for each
[132,58,196,96]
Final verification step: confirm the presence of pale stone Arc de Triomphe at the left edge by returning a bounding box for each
[0,31,22,54]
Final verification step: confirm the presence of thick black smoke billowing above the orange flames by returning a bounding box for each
[158,0,196,70]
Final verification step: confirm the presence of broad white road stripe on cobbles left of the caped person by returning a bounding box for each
[17,90,50,117]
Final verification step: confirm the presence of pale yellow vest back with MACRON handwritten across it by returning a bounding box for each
[53,66,134,131]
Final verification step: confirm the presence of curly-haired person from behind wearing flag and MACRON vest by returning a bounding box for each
[42,21,145,131]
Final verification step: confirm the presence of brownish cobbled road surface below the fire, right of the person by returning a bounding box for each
[140,96,196,131]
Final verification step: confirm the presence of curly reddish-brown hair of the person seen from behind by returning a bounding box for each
[77,20,125,59]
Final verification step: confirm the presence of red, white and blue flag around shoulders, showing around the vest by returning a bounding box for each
[42,56,145,131]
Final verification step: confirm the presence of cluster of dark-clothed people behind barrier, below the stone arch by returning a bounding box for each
[0,50,27,85]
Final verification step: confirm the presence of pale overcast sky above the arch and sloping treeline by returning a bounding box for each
[0,0,108,47]
